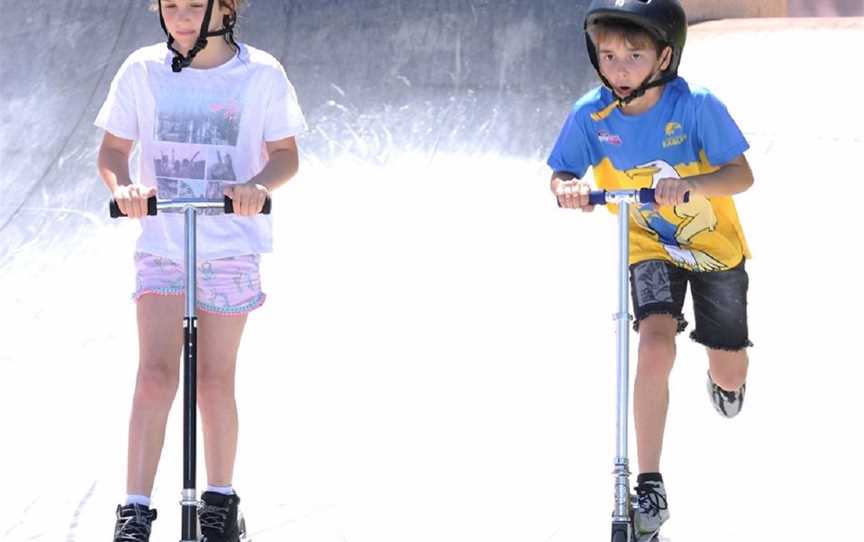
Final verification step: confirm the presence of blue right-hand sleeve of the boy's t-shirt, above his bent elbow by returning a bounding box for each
[696,93,750,166]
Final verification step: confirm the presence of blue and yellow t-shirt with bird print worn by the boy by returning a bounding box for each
[548,77,750,271]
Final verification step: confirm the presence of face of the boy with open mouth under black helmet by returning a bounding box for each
[597,35,671,98]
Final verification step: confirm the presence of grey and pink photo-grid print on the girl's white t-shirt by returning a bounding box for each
[153,88,243,214]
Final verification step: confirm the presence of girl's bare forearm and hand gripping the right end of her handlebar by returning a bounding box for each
[225,137,300,216]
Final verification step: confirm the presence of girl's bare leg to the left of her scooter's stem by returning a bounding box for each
[126,295,183,496]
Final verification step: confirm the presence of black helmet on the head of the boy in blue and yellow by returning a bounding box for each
[585,0,687,78]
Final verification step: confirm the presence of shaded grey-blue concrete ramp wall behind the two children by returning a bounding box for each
[0,0,594,267]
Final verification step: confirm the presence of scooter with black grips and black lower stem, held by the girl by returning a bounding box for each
[109,196,272,542]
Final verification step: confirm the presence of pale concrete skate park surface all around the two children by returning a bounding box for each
[0,0,864,542]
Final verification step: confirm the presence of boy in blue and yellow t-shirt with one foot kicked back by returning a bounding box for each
[548,0,753,539]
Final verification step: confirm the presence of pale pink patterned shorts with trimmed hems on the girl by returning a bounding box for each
[132,252,266,315]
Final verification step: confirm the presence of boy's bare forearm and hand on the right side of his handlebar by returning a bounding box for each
[655,154,753,205]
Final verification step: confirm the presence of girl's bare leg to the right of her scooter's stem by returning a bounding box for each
[198,312,247,486]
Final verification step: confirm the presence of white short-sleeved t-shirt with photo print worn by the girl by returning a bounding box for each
[94,43,306,261]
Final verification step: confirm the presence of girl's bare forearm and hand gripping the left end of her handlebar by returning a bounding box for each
[96,131,156,218]
